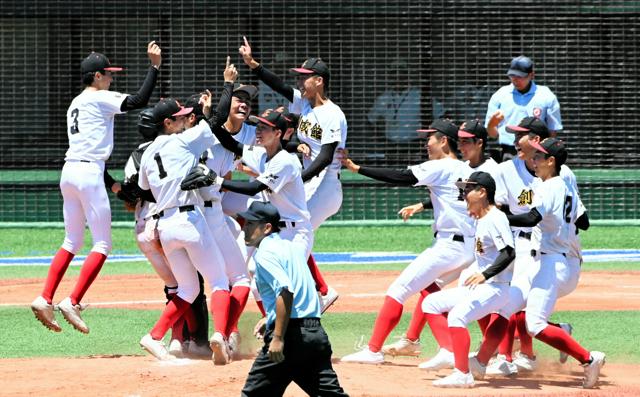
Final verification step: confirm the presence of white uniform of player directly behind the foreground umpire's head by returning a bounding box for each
[242,145,314,257]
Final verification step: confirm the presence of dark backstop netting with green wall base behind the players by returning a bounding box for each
[0,0,640,222]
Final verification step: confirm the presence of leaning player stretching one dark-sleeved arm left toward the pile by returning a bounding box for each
[342,120,475,365]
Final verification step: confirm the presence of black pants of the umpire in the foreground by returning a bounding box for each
[242,318,348,397]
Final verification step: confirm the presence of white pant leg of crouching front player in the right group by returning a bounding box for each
[444,283,509,328]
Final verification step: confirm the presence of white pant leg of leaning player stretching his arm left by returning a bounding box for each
[387,237,473,303]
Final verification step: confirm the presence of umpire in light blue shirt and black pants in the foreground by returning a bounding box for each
[238,201,347,396]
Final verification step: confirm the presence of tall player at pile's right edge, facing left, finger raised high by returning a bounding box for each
[239,37,347,311]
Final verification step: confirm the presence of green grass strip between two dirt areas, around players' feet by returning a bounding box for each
[0,303,640,363]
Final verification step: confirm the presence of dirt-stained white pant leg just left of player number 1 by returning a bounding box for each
[135,219,178,287]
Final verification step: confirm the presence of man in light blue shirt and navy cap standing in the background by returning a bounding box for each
[485,55,562,161]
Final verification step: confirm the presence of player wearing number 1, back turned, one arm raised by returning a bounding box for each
[138,57,237,365]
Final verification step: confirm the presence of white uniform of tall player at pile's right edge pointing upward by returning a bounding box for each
[289,89,347,230]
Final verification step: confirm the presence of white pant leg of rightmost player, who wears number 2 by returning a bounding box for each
[525,254,567,336]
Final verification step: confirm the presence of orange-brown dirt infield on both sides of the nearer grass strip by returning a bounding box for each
[0,271,640,396]
